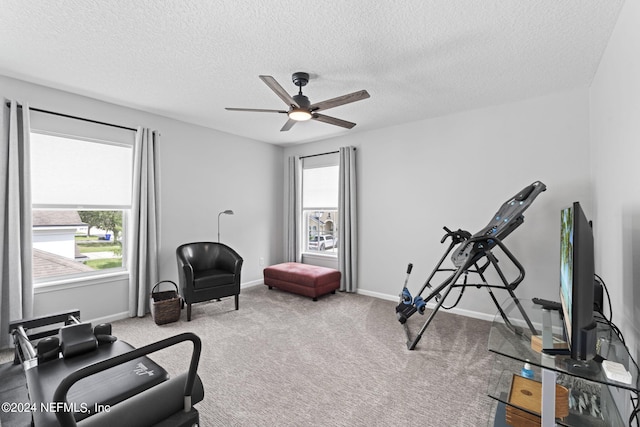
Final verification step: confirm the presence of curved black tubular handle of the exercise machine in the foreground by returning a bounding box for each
[53,332,202,427]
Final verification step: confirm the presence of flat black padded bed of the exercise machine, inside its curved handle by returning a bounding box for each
[25,341,169,427]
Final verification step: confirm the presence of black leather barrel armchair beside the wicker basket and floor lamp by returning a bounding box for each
[176,242,243,321]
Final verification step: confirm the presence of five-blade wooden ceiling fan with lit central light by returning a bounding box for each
[225,72,369,132]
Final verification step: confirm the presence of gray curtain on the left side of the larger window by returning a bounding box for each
[0,100,33,348]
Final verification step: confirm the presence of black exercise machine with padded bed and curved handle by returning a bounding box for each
[9,310,204,427]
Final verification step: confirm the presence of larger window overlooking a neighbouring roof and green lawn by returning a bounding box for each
[31,130,134,284]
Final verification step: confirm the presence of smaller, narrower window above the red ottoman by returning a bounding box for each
[301,153,339,257]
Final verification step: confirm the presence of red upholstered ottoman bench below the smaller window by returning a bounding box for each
[264,262,341,301]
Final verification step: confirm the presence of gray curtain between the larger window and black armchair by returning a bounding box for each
[128,127,159,317]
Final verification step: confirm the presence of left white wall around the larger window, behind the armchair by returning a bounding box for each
[0,76,284,320]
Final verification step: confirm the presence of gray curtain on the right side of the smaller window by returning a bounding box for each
[338,147,358,292]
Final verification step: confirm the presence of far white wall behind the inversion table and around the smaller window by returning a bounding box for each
[284,88,591,317]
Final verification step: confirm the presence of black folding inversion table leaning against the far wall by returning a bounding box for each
[396,181,547,350]
